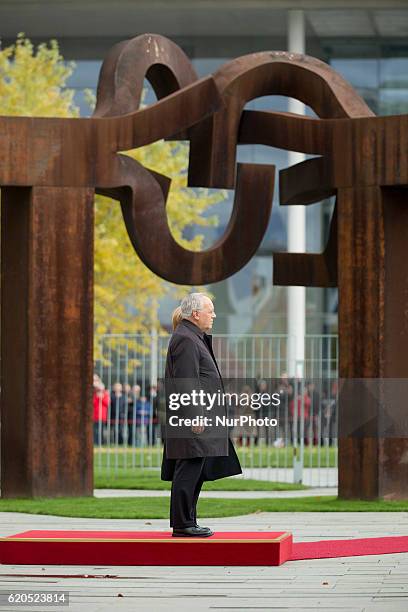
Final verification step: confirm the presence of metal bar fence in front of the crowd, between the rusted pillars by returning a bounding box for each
[94,333,338,487]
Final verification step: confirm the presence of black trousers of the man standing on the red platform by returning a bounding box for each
[170,457,205,529]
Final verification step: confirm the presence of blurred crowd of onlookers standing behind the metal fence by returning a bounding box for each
[93,373,337,448]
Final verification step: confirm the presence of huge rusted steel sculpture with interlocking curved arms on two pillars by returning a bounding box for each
[0,35,408,499]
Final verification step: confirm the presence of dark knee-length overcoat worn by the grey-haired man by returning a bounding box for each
[162,319,242,480]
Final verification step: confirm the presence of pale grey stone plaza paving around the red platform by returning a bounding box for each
[0,512,408,612]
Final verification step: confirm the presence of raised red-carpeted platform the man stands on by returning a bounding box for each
[0,530,292,565]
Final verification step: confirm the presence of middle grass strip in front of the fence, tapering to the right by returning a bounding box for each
[94,468,308,491]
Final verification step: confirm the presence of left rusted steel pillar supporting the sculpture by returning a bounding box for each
[1,187,94,497]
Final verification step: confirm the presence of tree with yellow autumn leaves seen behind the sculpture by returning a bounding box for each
[0,34,225,350]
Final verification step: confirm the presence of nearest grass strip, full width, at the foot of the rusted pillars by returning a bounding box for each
[0,497,408,520]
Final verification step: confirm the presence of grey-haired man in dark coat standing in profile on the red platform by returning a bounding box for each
[162,293,242,537]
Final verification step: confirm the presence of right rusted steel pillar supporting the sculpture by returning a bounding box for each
[337,185,408,499]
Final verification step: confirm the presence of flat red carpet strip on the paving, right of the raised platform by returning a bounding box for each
[290,536,408,561]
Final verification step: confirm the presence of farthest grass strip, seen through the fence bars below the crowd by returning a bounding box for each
[94,446,337,474]
